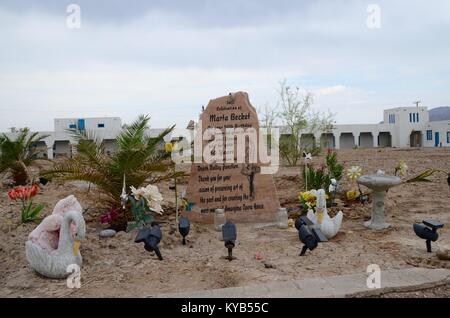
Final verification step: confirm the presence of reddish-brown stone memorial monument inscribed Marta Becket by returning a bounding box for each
[184,92,280,223]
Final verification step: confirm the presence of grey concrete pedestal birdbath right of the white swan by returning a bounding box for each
[356,171,402,230]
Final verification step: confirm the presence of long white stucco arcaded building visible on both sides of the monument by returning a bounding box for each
[3,107,450,159]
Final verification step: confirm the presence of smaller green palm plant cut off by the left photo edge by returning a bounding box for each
[0,128,48,185]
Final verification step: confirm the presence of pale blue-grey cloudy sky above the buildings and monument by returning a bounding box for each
[0,0,450,131]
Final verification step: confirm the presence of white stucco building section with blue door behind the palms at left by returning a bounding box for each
[1,117,170,159]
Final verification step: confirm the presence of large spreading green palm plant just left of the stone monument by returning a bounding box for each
[43,115,182,230]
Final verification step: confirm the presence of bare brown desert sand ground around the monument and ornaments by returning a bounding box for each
[0,149,450,297]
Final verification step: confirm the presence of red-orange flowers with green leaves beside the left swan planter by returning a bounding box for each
[8,184,45,223]
